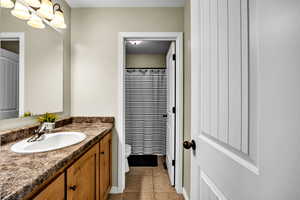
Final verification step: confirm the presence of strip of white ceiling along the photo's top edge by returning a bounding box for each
[66,0,185,7]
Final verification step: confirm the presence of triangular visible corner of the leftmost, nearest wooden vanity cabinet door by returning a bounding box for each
[34,173,65,200]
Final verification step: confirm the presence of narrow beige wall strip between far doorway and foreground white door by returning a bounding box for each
[183,0,191,195]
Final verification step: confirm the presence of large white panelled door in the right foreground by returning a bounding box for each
[190,0,300,200]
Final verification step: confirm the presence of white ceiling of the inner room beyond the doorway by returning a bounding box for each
[126,40,171,54]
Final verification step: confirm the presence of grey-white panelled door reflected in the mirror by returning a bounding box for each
[0,48,19,119]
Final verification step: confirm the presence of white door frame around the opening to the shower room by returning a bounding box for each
[116,32,183,193]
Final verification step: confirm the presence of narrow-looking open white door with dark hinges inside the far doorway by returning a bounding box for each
[166,42,176,185]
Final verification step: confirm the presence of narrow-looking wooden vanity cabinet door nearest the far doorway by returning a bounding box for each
[100,133,112,200]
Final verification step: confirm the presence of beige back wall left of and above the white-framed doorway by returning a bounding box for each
[71,8,184,188]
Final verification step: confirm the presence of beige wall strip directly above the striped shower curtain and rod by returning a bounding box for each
[126,54,166,68]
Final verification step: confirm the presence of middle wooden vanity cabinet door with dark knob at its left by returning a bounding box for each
[67,144,99,200]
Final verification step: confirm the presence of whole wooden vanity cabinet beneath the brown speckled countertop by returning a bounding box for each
[30,133,112,200]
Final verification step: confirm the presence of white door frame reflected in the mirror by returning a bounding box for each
[0,32,25,117]
